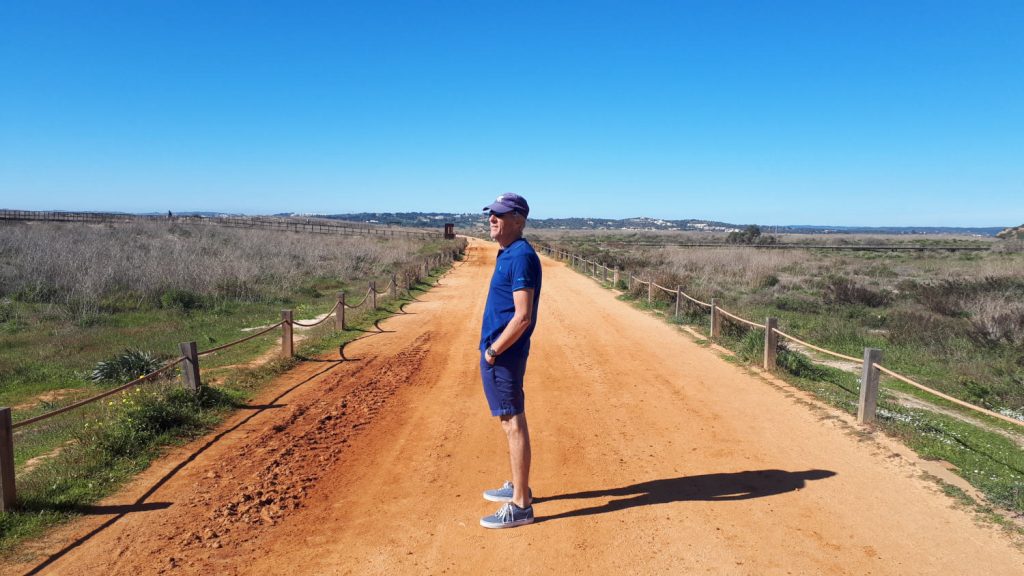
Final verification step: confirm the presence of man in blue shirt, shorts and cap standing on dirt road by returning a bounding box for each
[480,194,541,528]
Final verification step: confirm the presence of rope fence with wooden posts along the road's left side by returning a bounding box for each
[0,243,465,512]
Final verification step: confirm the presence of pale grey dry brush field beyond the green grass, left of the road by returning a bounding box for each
[0,221,446,316]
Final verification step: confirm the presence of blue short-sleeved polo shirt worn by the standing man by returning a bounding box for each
[480,238,541,356]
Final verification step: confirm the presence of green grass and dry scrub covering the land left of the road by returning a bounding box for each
[0,222,463,553]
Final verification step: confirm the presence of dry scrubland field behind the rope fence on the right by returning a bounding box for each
[538,228,1024,410]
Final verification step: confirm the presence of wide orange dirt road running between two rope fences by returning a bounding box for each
[2,235,1024,576]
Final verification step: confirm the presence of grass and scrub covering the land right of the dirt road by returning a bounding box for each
[530,231,1024,513]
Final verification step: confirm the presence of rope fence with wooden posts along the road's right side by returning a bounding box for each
[541,240,1024,426]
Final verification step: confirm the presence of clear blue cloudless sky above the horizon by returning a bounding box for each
[0,0,1024,225]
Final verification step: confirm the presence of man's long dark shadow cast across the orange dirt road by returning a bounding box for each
[534,469,836,522]
